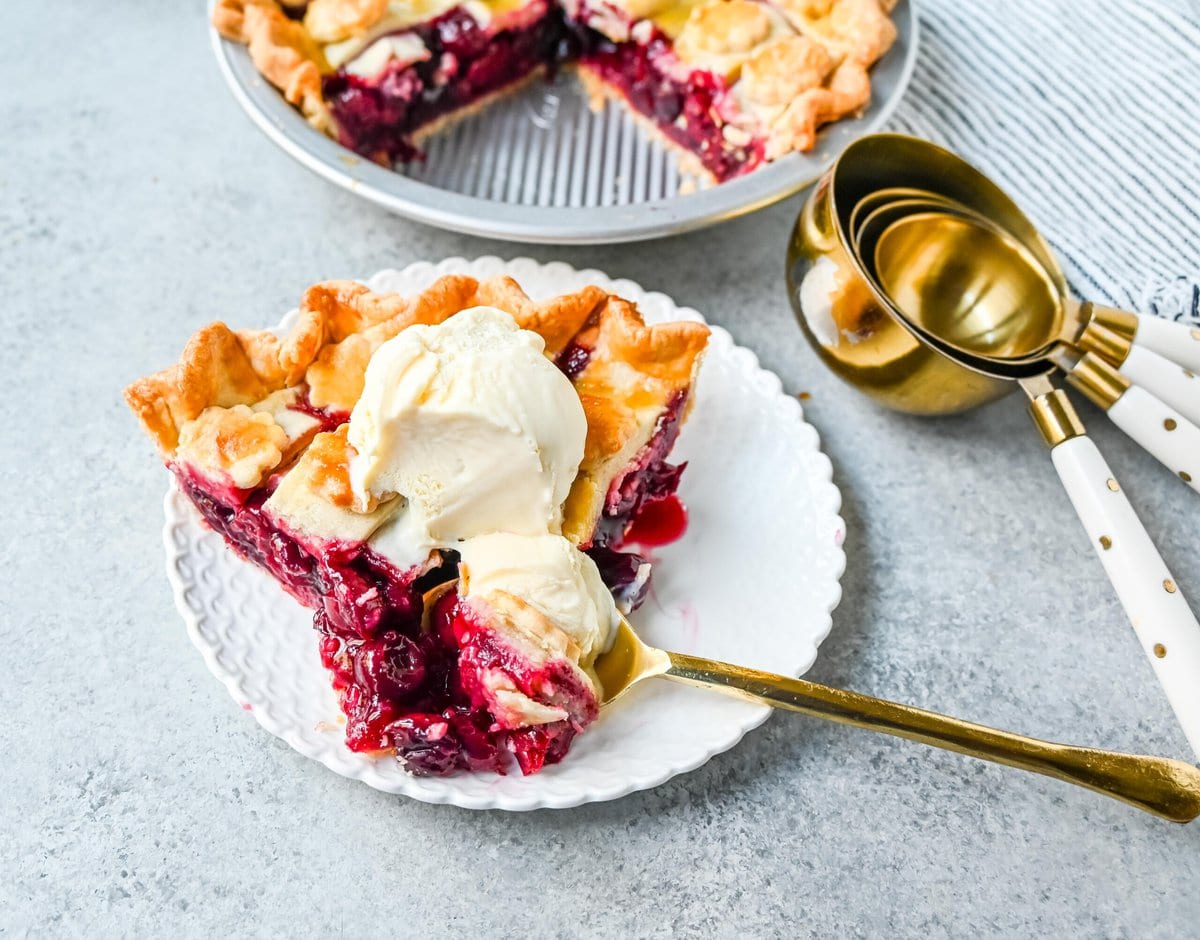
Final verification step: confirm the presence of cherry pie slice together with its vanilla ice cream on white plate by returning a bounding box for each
[126,276,708,774]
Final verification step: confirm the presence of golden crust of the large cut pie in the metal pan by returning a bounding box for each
[212,0,896,178]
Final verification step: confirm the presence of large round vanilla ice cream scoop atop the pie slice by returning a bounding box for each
[349,307,588,545]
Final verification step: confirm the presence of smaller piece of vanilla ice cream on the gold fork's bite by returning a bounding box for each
[458,532,619,669]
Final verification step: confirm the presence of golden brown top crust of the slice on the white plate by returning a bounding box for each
[125,275,708,552]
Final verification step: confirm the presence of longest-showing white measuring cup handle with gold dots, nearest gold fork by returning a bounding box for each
[1050,436,1200,756]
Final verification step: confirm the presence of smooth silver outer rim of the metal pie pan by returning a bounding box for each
[209,0,920,245]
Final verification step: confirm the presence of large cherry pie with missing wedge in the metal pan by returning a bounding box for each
[212,0,896,180]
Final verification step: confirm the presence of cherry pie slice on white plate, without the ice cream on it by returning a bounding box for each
[126,275,708,774]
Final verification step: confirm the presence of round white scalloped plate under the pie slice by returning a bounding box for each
[163,257,845,810]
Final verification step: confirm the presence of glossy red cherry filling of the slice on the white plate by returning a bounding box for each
[170,381,686,776]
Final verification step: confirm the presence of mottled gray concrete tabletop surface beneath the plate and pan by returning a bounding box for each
[0,0,1200,936]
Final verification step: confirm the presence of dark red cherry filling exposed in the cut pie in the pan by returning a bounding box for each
[323,0,763,180]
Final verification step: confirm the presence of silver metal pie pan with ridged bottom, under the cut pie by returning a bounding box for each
[211,0,918,245]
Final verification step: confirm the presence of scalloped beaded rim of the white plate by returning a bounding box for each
[162,256,846,812]
